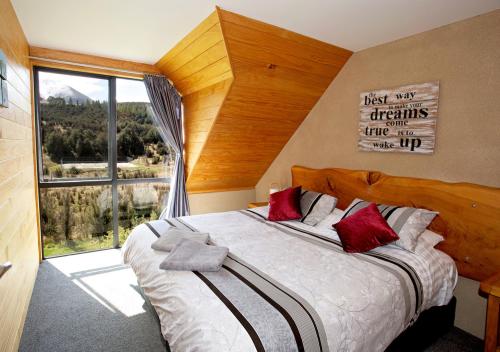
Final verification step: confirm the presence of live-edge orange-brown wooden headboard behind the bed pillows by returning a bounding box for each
[292,166,500,281]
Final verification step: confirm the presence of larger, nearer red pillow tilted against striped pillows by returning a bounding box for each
[333,203,399,253]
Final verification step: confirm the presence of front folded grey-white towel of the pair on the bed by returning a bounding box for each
[160,239,229,271]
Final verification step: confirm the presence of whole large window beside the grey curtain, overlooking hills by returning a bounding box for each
[35,68,175,257]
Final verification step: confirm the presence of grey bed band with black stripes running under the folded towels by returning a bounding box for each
[146,218,328,352]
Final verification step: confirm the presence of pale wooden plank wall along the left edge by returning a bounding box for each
[0,0,39,351]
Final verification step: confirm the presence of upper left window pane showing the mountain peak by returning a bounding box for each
[38,71,110,181]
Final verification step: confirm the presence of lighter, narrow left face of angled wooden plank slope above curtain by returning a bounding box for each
[156,12,233,182]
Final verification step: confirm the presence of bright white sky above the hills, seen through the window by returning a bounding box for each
[39,71,149,103]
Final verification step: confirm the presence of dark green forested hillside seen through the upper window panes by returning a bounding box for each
[40,97,171,179]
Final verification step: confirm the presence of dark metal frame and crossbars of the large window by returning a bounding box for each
[33,66,171,259]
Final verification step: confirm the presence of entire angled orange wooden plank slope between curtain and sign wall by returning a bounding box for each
[156,9,352,192]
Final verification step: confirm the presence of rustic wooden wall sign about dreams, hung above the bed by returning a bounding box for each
[358,81,439,154]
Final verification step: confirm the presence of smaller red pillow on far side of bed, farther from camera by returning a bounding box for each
[267,186,302,221]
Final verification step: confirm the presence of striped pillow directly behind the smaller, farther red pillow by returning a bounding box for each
[300,191,337,226]
